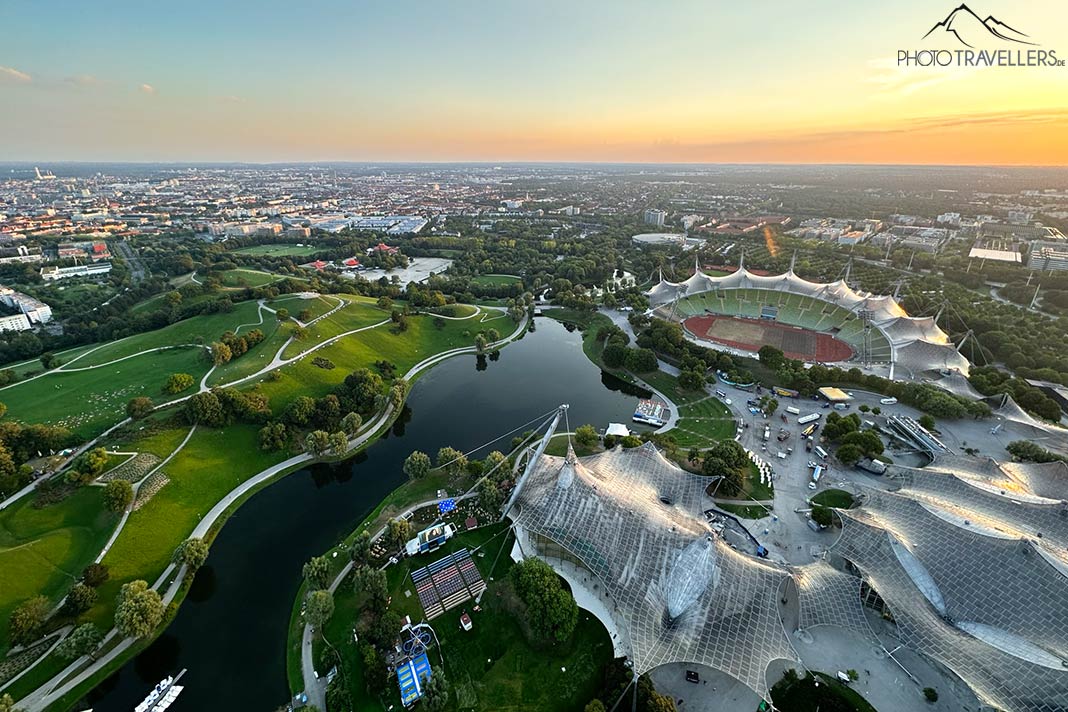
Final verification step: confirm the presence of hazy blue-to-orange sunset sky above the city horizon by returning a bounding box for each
[0,0,1068,165]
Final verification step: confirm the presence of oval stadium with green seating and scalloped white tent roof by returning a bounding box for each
[646,266,970,378]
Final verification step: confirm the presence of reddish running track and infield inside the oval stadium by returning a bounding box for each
[682,315,853,363]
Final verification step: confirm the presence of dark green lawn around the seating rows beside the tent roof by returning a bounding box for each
[313,524,612,712]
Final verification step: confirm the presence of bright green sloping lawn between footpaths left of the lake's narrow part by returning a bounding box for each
[88,424,285,627]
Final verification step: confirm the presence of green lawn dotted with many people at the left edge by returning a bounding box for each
[0,347,208,440]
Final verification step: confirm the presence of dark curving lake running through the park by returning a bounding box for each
[85,318,635,712]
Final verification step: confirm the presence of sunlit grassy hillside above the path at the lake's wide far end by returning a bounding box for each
[258,315,515,411]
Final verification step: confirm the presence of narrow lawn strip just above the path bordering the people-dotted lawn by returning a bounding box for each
[65,301,267,368]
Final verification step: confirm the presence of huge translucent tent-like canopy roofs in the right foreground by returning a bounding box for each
[497,409,1068,712]
